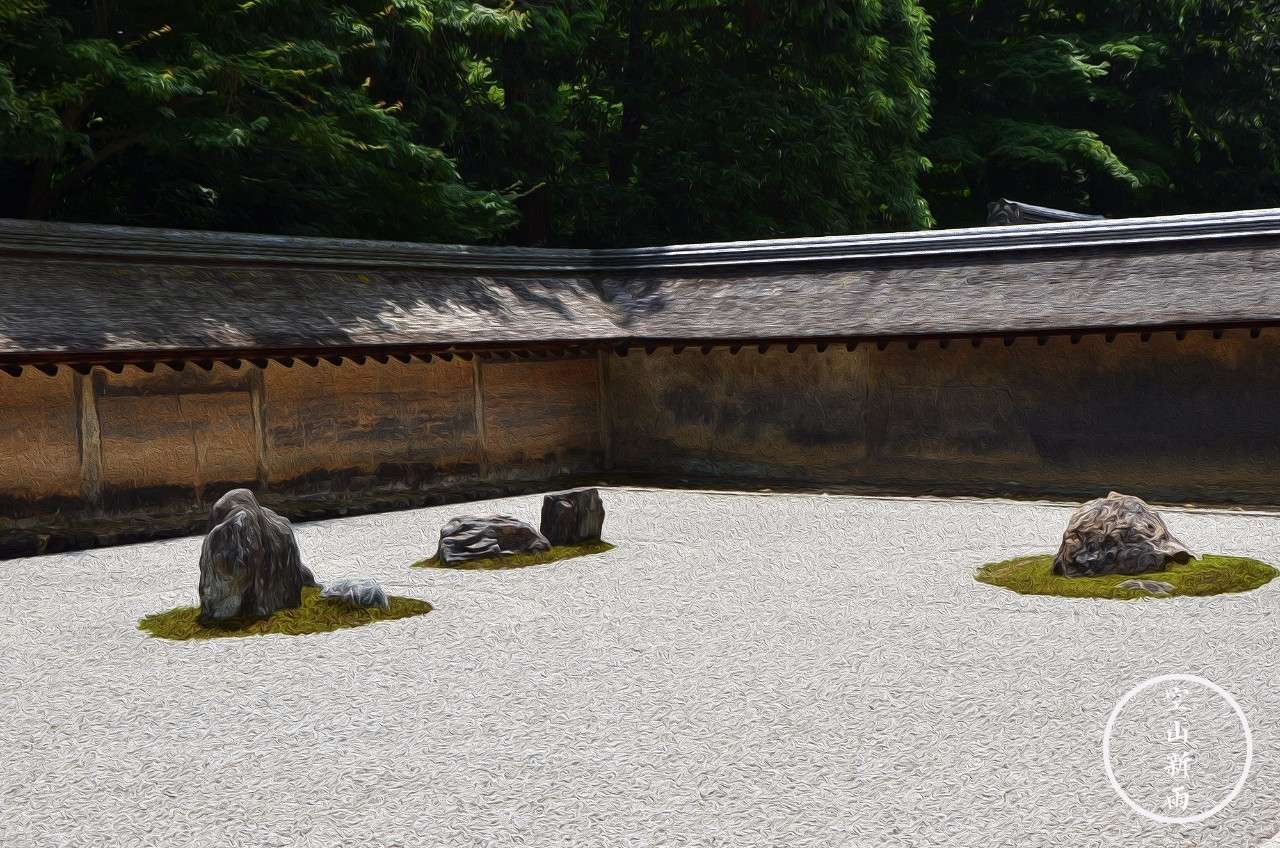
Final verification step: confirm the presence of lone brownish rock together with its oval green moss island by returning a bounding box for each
[978,492,1277,599]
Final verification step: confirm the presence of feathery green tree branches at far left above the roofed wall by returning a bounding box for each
[0,0,520,241]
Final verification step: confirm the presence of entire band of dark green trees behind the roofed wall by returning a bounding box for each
[0,0,1280,247]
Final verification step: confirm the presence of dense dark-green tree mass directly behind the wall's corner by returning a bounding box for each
[463,0,932,246]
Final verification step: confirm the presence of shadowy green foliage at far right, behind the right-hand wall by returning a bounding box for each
[924,0,1280,225]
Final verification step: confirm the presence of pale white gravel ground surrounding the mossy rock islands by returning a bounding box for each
[0,489,1280,848]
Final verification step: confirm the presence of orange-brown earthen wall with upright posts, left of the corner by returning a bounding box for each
[0,357,603,557]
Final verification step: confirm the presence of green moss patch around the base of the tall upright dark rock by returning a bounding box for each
[138,588,431,639]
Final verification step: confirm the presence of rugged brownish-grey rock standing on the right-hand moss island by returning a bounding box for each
[1053,492,1193,578]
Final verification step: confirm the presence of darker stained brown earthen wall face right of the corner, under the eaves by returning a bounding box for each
[608,330,1280,503]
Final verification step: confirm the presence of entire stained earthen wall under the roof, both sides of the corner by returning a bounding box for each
[0,330,1280,556]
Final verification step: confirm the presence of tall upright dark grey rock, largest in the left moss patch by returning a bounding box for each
[200,489,316,621]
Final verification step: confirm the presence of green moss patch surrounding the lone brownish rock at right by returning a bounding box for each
[978,553,1277,601]
